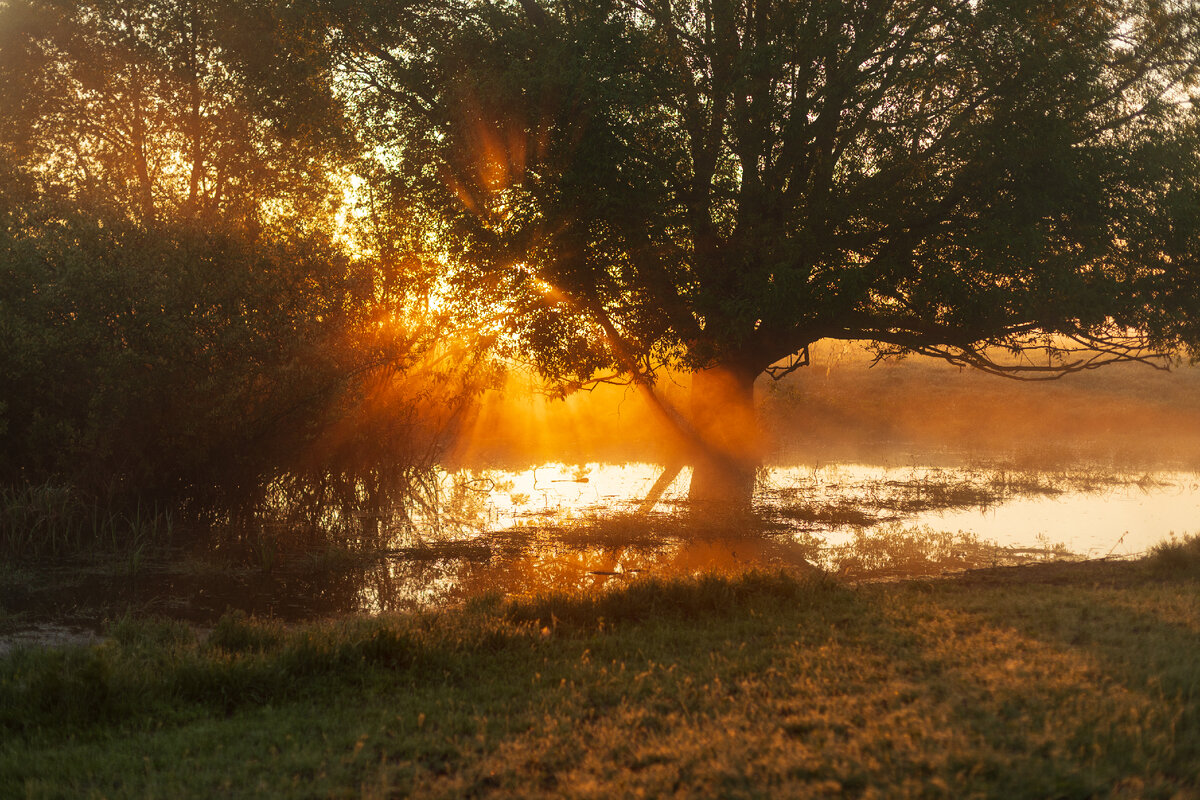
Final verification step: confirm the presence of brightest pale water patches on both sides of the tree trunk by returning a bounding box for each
[462,464,1200,558]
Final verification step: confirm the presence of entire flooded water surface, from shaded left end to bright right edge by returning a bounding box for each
[0,463,1200,638]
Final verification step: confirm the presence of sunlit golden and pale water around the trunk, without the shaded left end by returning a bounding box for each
[340,464,1200,610]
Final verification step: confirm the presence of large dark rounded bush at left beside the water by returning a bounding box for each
[0,204,477,558]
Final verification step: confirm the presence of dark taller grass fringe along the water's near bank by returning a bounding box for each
[0,573,816,732]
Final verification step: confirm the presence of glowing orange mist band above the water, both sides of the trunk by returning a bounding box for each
[448,342,1200,471]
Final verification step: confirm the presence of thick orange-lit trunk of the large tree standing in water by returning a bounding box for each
[688,367,762,511]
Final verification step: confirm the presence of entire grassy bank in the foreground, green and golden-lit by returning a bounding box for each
[0,541,1200,798]
